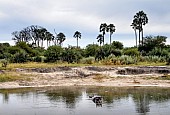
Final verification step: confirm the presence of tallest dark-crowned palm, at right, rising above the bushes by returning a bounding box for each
[132,11,148,45]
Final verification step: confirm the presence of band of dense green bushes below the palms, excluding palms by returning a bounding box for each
[0,36,170,65]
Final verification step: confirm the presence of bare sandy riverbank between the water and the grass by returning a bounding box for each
[0,66,170,89]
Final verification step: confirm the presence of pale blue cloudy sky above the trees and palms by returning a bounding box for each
[0,0,170,47]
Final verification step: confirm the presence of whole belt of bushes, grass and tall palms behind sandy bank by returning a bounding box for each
[0,11,170,69]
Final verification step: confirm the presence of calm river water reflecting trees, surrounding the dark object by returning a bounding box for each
[0,87,170,115]
